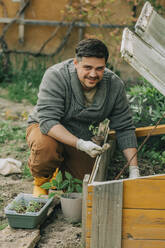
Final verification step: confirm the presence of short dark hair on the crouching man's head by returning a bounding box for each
[75,39,109,62]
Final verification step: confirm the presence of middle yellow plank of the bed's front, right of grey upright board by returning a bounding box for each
[122,209,165,240]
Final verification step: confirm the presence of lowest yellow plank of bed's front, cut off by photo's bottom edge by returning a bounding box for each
[122,239,165,248]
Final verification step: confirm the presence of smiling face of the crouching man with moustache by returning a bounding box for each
[74,57,105,90]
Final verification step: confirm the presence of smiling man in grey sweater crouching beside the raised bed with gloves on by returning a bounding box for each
[27,39,139,195]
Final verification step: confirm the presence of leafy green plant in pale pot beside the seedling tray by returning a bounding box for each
[42,171,82,223]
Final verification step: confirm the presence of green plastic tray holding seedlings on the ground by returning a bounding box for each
[5,193,53,229]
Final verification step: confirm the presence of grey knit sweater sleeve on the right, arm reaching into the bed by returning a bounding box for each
[110,79,137,151]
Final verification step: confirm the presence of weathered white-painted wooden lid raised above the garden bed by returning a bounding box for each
[121,2,165,95]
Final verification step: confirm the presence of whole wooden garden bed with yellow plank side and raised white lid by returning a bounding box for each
[82,2,165,248]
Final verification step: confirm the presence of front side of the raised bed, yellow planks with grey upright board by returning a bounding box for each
[85,174,165,248]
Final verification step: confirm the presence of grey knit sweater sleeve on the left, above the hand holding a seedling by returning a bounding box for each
[37,68,65,134]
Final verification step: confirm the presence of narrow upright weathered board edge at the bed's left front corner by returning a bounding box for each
[82,174,90,247]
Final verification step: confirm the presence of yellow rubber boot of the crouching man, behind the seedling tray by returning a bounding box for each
[33,177,50,197]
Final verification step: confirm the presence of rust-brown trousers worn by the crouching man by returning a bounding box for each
[26,123,95,179]
